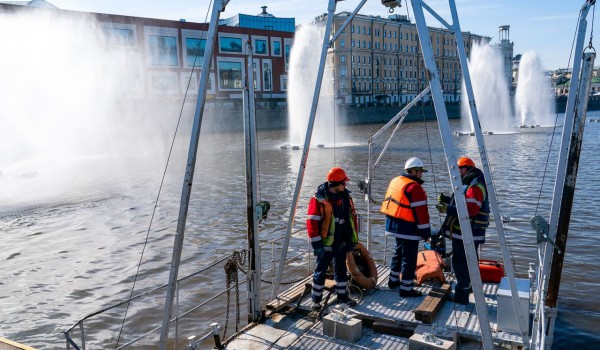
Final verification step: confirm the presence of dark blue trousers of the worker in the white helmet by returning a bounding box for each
[389,238,419,291]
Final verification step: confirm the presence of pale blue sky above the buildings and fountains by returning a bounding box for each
[48,0,600,70]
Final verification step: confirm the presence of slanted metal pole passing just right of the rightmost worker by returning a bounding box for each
[449,0,529,346]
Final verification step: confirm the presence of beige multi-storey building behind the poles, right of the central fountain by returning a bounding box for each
[328,12,491,106]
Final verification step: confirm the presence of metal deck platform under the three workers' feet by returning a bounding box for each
[226,266,521,350]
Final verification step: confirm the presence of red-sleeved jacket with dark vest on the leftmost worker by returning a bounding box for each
[306,183,358,250]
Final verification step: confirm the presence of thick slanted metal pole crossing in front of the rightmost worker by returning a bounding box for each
[412,0,494,350]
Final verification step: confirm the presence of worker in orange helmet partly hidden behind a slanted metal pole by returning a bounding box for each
[437,157,490,305]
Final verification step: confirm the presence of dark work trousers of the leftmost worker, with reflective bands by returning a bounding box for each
[311,248,348,303]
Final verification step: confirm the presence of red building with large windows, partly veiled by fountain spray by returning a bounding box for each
[0,3,295,104]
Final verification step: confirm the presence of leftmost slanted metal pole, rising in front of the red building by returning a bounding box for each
[159,0,229,350]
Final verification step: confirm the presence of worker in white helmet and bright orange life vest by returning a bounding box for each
[381,157,431,298]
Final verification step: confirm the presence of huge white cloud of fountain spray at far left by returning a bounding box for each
[0,11,180,210]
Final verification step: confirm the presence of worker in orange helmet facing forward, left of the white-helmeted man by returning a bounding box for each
[306,167,358,310]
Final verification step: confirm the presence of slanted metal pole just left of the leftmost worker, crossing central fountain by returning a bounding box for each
[272,0,336,299]
